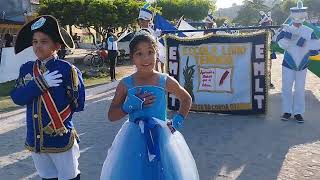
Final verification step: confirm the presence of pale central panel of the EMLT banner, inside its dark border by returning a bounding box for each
[179,43,252,105]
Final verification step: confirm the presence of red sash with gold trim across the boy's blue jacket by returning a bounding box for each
[33,62,71,135]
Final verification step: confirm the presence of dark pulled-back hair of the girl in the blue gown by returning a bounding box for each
[129,30,158,57]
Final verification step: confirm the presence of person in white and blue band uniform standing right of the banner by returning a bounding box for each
[277,0,320,123]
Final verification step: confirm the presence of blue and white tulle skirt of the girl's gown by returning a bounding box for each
[100,117,199,180]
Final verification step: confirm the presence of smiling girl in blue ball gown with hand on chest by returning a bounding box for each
[100,30,199,180]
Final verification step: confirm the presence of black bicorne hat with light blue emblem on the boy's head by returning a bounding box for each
[14,15,74,54]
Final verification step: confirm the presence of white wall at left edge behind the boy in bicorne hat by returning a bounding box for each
[0,47,37,83]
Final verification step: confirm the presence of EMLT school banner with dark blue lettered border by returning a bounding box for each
[166,33,268,114]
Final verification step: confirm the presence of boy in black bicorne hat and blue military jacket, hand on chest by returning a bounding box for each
[10,15,85,180]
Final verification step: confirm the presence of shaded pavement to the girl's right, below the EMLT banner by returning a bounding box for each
[182,91,320,180]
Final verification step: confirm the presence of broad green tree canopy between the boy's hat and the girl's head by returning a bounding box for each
[39,0,141,43]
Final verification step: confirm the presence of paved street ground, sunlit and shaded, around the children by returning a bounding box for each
[0,54,320,180]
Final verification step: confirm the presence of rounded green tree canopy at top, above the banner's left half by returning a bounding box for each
[154,0,215,21]
